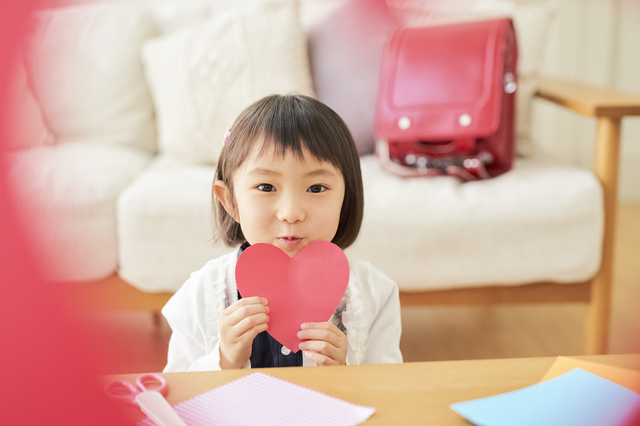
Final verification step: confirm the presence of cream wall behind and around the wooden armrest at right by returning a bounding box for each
[533,0,640,202]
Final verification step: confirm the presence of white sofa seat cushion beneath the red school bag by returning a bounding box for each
[348,154,603,291]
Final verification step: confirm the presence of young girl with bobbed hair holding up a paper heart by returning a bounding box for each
[162,95,402,372]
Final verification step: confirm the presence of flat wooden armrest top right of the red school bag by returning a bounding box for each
[535,77,640,117]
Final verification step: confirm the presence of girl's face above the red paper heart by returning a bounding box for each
[214,143,345,257]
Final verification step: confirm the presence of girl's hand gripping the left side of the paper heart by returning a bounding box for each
[218,297,269,370]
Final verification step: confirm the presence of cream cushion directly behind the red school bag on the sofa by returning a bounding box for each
[387,0,557,156]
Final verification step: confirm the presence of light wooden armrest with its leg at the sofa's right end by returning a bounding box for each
[536,77,640,354]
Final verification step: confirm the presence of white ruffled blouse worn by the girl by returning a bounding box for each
[162,251,402,372]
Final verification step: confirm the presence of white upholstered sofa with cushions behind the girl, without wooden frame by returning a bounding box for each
[8,0,603,300]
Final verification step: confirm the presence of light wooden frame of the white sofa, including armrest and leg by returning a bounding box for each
[64,78,640,355]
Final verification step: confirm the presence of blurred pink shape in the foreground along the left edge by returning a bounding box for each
[0,0,126,425]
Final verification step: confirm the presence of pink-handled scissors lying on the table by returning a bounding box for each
[104,373,187,426]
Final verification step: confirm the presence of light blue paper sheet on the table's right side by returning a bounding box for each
[451,368,640,426]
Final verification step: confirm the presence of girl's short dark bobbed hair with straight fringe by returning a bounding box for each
[212,94,364,250]
